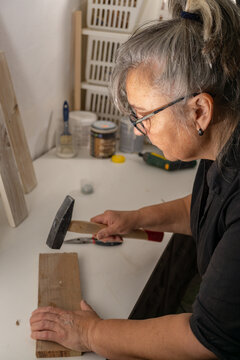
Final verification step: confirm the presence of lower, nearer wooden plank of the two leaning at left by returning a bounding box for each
[0,104,28,227]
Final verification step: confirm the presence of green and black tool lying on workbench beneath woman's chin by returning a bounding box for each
[138,152,197,171]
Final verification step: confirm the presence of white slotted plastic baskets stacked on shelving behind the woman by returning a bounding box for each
[81,0,171,123]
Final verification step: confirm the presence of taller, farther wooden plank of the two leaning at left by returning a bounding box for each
[0,52,37,193]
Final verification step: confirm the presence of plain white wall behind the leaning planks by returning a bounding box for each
[0,0,86,158]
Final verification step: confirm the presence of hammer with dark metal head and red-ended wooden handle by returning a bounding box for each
[46,195,163,249]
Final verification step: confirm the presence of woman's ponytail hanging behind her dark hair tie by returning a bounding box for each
[168,0,240,79]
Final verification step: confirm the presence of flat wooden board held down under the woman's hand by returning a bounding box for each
[36,253,81,358]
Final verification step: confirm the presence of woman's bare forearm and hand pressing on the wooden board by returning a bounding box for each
[30,302,216,360]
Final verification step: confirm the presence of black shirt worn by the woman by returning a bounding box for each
[190,127,240,360]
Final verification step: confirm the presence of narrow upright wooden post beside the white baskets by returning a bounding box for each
[73,11,82,110]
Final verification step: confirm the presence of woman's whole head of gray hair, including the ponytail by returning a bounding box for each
[111,0,240,125]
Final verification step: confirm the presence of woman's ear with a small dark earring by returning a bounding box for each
[189,93,213,132]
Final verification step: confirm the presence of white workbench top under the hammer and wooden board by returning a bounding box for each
[0,150,196,360]
